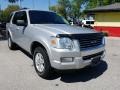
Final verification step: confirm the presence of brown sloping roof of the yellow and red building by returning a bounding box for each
[86,3,120,12]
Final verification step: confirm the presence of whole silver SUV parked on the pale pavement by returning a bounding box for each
[7,9,105,78]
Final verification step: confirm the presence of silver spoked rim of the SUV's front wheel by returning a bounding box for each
[35,53,45,72]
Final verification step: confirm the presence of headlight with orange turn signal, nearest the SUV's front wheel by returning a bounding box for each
[51,37,73,49]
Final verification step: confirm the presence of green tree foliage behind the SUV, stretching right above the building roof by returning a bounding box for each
[50,0,120,18]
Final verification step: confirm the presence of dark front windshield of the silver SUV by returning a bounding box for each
[29,10,68,24]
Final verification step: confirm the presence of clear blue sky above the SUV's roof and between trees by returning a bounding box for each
[0,0,57,10]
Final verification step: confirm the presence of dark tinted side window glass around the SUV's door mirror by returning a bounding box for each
[12,11,28,24]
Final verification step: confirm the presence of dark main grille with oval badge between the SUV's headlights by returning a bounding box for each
[78,34,103,50]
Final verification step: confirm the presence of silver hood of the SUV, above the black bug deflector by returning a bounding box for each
[34,24,96,35]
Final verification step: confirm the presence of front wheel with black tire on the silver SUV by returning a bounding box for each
[33,47,52,79]
